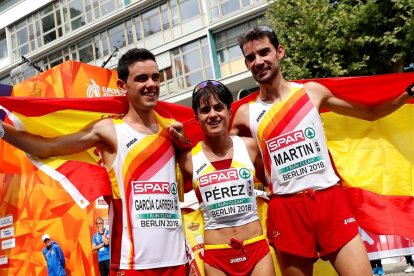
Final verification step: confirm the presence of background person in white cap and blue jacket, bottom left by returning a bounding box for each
[42,234,66,276]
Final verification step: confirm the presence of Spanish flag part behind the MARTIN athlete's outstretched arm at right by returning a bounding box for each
[316,73,414,239]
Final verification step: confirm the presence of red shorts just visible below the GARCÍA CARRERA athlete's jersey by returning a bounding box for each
[109,265,188,276]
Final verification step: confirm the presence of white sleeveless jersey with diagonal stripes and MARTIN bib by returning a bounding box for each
[249,83,339,195]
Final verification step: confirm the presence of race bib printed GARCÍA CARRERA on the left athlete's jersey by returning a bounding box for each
[131,181,181,228]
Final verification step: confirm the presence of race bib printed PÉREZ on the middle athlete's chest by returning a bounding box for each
[198,168,255,219]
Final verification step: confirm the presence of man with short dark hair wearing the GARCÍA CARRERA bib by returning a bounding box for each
[0,48,187,275]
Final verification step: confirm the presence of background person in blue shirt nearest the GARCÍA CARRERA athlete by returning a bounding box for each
[92,217,110,276]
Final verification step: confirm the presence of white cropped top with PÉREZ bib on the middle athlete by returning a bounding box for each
[192,136,259,230]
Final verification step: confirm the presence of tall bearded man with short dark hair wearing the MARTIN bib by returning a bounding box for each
[231,26,414,276]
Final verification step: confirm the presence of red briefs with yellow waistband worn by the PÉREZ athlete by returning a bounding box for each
[204,235,270,276]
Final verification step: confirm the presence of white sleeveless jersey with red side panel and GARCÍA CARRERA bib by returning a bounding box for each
[109,119,187,269]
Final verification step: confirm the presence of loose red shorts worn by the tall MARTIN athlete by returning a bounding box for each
[267,185,358,258]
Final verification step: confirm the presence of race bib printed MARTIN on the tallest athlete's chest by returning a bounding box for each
[266,126,326,183]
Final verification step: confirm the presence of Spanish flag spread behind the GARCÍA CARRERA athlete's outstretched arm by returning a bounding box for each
[0,96,193,208]
